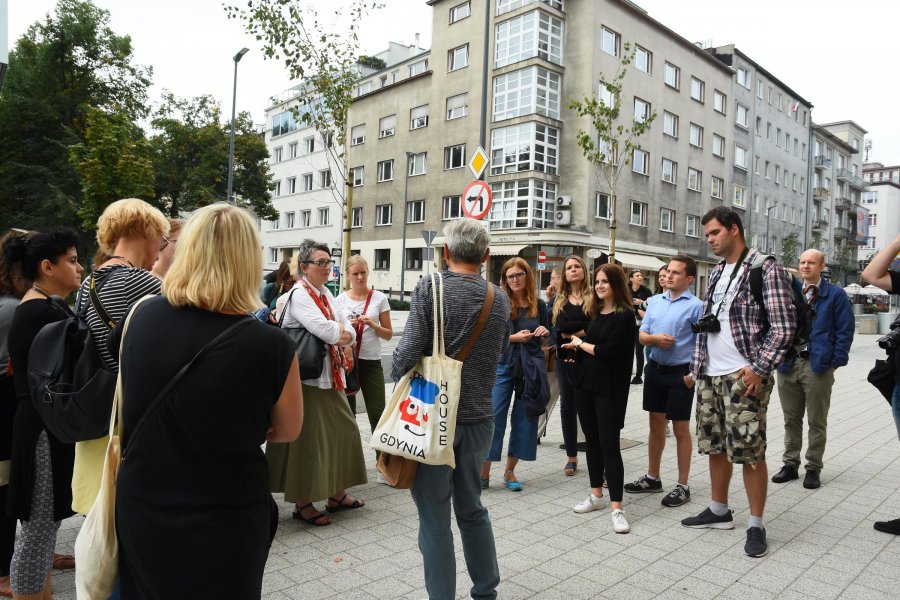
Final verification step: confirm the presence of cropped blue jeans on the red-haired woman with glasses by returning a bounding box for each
[487,363,538,462]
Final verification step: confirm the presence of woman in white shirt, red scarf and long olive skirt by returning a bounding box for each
[266,240,367,527]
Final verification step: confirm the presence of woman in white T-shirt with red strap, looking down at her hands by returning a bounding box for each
[337,255,394,431]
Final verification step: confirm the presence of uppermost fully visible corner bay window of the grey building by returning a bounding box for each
[494,10,563,68]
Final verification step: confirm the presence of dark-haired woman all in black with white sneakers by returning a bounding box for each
[563,264,636,533]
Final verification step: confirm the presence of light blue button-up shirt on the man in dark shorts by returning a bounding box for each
[641,290,703,365]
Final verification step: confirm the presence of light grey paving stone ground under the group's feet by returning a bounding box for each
[53,335,900,600]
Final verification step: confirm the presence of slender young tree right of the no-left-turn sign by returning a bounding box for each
[569,42,656,262]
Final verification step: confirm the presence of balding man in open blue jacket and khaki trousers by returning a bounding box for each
[772,250,855,490]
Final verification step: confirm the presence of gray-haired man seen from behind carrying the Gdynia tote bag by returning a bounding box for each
[391,219,509,600]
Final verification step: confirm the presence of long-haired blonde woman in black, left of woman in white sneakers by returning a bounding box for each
[551,254,591,476]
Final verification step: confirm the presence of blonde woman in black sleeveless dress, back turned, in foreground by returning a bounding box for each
[116,204,303,599]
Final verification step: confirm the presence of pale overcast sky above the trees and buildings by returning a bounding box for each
[9,0,900,164]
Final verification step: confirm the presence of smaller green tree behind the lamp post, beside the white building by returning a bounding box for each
[150,92,277,219]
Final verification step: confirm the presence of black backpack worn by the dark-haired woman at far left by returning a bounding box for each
[28,275,117,443]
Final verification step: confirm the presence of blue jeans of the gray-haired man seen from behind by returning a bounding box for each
[411,419,500,600]
